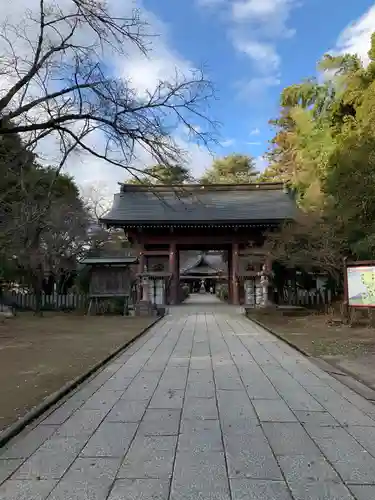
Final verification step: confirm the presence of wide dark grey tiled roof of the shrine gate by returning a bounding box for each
[102,183,297,225]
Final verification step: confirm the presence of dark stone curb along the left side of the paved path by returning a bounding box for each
[0,315,164,450]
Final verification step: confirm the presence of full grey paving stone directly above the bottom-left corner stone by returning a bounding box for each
[13,437,83,479]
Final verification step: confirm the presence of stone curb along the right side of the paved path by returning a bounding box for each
[245,313,375,403]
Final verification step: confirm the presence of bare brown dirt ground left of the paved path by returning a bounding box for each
[0,313,153,432]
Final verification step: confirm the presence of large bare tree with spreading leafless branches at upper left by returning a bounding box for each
[0,0,214,175]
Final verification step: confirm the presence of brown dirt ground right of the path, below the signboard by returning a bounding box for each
[250,311,375,389]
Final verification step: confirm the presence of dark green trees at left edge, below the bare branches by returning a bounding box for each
[0,129,91,304]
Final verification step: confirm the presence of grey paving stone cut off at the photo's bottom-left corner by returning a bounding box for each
[0,480,56,500]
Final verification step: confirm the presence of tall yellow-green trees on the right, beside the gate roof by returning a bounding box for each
[261,30,375,278]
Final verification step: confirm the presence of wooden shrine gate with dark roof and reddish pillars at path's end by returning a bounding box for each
[101,183,297,305]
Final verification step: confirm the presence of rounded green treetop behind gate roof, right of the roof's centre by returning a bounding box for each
[200,154,258,184]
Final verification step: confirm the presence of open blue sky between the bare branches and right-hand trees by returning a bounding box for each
[142,0,375,173]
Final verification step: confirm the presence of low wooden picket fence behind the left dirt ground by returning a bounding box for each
[4,292,89,311]
